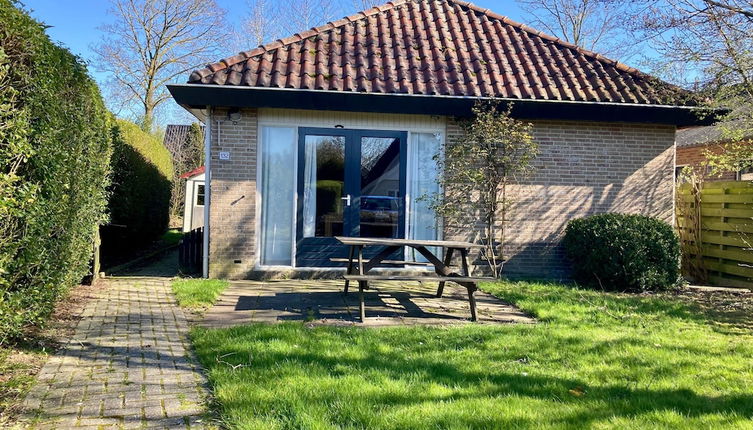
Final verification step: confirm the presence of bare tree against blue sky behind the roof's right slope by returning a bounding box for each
[517,0,632,57]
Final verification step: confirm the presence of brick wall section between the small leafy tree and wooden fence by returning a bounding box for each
[447,121,675,278]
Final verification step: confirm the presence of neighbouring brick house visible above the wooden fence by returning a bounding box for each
[675,126,753,181]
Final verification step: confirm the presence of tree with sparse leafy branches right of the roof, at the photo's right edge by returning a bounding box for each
[642,0,753,173]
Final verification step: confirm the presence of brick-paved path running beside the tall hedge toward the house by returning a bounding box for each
[25,278,205,429]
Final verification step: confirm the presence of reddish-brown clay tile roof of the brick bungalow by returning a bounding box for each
[189,0,690,104]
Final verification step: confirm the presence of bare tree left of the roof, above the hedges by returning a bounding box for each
[94,0,224,132]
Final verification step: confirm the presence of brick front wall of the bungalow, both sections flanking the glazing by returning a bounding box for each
[209,110,675,278]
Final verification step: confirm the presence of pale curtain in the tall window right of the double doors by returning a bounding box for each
[408,133,442,261]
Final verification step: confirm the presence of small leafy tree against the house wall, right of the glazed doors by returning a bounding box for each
[424,102,538,276]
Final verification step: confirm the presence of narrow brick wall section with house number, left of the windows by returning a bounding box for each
[209,110,258,279]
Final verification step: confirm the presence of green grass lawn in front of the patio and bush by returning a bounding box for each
[192,282,753,429]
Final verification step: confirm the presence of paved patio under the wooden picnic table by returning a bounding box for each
[200,279,535,328]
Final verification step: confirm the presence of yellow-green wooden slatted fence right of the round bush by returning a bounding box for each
[677,181,753,288]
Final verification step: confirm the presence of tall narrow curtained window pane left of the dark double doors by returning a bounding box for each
[258,127,296,266]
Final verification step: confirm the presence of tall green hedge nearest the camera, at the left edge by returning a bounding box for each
[0,0,114,344]
